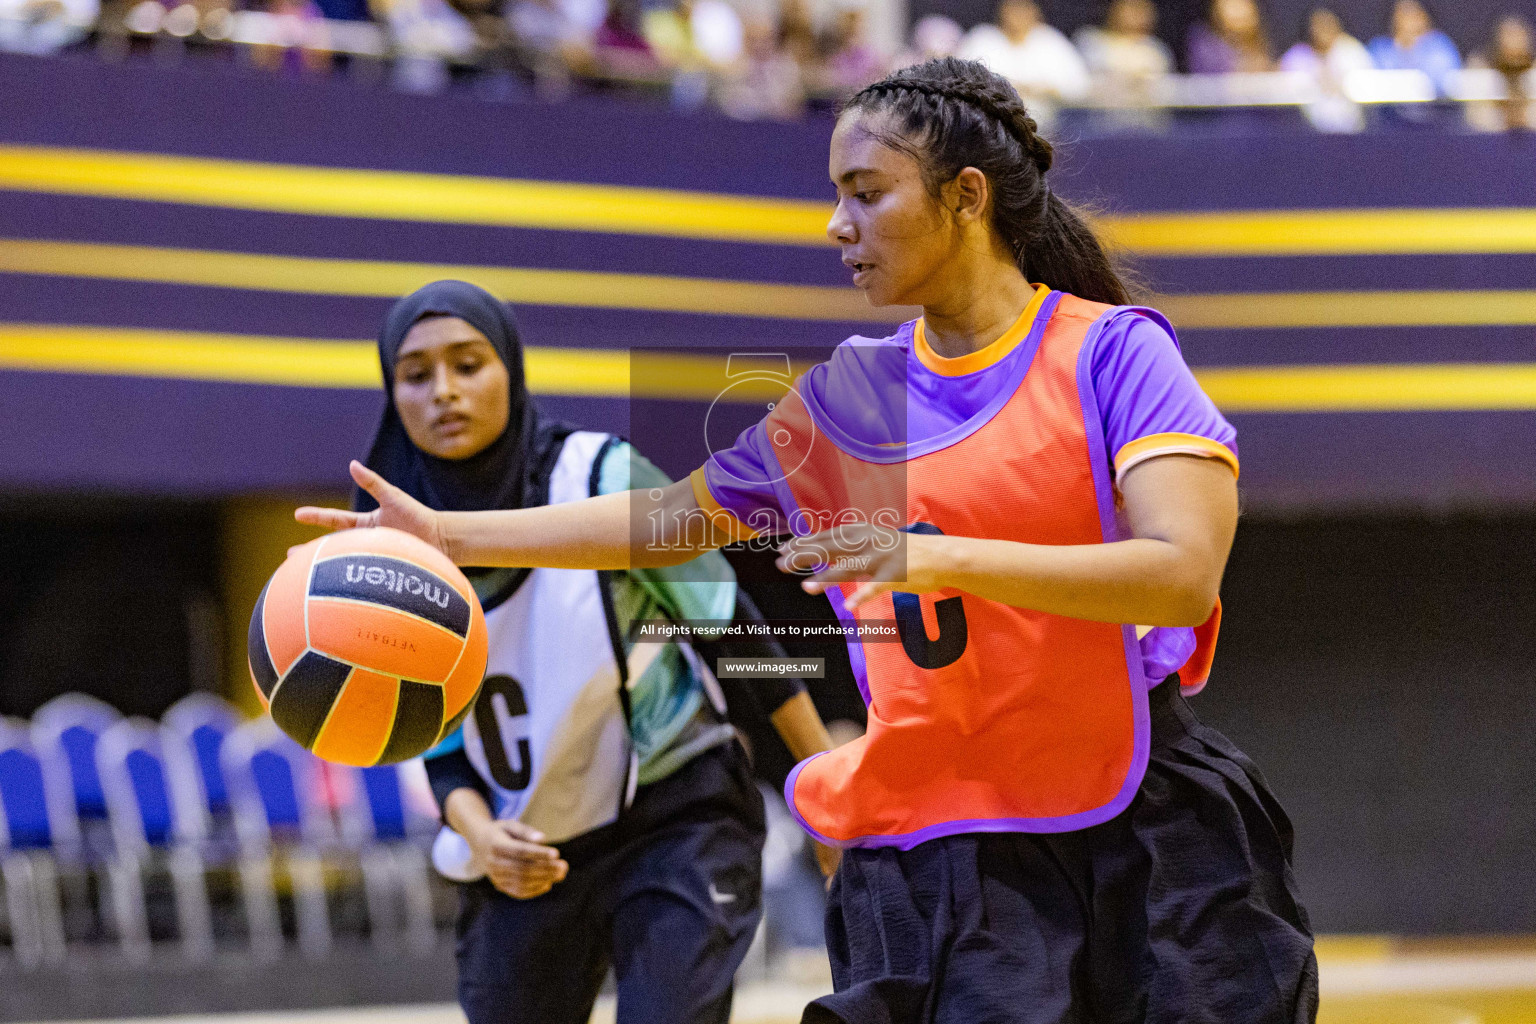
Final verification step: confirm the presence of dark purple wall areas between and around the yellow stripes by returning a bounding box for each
[0,57,1536,508]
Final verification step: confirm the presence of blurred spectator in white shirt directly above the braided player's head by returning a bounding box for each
[960,0,1091,121]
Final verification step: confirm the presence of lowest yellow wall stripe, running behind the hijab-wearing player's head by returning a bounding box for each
[0,324,1536,413]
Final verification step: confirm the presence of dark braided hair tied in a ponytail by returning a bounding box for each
[843,57,1129,306]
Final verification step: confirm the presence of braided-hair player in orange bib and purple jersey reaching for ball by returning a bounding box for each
[298,58,1316,1024]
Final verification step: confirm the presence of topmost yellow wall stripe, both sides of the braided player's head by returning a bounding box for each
[9,146,1536,256]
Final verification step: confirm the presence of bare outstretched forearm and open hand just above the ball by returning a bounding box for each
[293,462,734,570]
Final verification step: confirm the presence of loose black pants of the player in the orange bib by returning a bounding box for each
[803,679,1318,1024]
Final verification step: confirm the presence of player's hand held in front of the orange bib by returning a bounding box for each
[777,524,943,611]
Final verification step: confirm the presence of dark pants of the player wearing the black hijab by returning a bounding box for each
[458,743,763,1024]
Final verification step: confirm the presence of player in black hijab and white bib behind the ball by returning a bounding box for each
[355,281,828,1024]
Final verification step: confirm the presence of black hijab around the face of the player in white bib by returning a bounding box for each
[352,281,574,511]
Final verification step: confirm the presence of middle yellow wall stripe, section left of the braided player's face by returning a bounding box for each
[0,238,914,322]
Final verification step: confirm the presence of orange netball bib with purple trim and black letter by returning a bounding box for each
[768,292,1149,849]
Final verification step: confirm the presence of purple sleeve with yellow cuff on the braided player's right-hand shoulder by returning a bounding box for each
[1092,312,1238,477]
